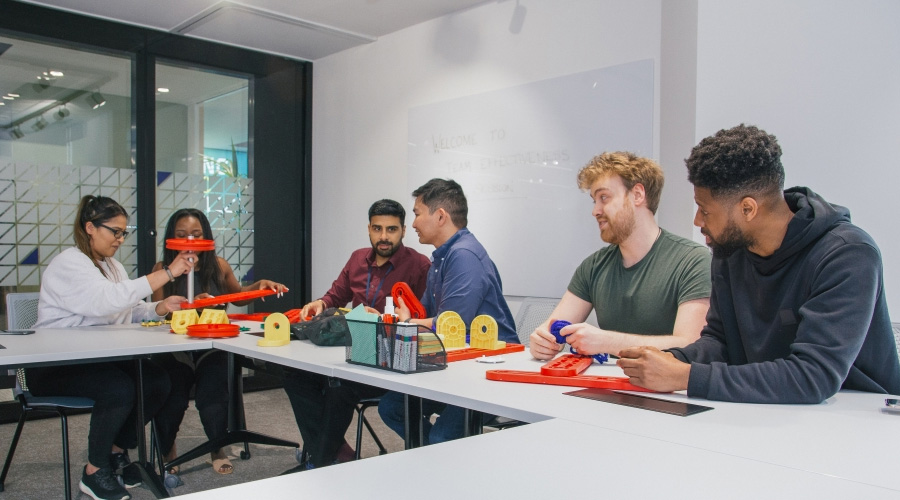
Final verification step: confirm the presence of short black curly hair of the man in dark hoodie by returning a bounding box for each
[685,123,784,197]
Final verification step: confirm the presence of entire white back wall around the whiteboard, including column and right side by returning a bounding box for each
[312,0,900,314]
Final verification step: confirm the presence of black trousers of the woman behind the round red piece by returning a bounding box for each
[153,350,231,455]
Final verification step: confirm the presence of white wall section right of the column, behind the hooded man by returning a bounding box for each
[696,0,900,317]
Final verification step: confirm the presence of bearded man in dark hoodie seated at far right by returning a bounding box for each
[618,125,900,403]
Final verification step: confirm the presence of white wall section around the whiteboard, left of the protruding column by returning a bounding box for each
[312,0,660,308]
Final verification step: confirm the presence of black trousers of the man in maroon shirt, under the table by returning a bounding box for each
[284,368,387,467]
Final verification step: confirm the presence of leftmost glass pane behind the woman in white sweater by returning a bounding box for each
[0,36,139,286]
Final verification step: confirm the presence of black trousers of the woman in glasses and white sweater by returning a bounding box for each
[26,360,170,467]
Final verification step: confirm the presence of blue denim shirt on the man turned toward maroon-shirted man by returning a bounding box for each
[422,228,519,343]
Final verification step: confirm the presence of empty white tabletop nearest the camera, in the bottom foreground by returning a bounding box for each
[171,420,898,500]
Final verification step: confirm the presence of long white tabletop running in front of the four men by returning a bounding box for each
[207,336,900,491]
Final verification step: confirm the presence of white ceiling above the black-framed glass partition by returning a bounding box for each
[22,0,492,61]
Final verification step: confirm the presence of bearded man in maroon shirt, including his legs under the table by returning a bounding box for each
[284,200,431,472]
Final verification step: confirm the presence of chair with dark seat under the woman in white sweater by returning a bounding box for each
[0,292,94,498]
